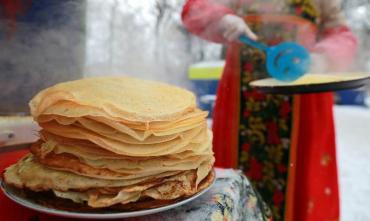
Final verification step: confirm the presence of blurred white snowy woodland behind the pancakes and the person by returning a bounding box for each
[85,0,370,87]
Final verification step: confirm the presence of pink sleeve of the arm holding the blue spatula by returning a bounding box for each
[181,0,233,43]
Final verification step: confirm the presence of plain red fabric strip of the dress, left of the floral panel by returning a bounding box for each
[213,45,240,168]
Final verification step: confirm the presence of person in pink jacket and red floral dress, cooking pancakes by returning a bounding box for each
[182,0,357,221]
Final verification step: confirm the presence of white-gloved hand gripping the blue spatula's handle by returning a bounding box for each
[218,14,257,42]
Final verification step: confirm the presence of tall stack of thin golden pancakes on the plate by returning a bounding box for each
[4,77,214,208]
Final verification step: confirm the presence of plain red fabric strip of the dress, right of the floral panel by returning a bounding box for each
[293,93,339,221]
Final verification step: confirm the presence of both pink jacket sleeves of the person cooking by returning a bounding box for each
[182,0,357,71]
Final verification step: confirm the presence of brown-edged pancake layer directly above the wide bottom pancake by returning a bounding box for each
[31,144,214,183]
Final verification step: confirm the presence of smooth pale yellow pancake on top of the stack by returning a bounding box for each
[30,76,196,122]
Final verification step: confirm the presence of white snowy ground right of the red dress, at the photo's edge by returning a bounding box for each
[334,106,370,221]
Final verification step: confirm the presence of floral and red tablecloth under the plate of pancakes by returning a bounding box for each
[0,151,269,221]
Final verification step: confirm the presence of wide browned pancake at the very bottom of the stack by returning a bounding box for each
[4,155,211,208]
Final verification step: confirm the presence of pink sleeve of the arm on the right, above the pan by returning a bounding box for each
[313,0,358,72]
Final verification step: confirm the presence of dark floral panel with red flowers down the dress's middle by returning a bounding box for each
[238,0,317,220]
